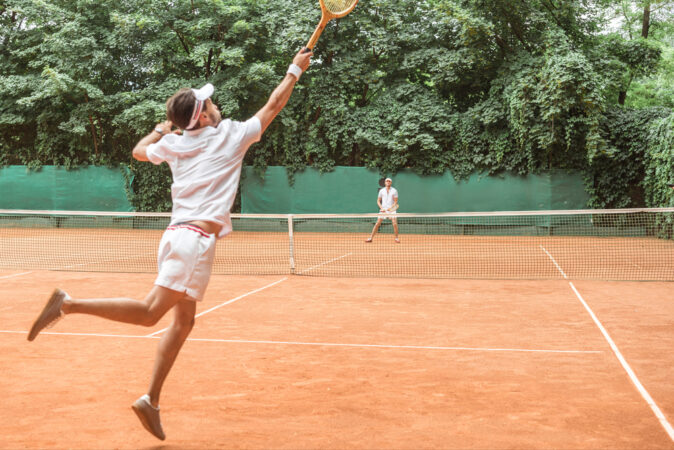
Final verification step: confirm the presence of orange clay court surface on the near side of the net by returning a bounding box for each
[0,270,674,449]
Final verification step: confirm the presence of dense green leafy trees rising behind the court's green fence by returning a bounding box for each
[0,0,674,210]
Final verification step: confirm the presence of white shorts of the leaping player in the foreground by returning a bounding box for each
[154,224,216,301]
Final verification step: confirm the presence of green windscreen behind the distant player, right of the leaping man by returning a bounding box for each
[241,166,588,214]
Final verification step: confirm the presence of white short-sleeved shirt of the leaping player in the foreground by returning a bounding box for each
[147,117,262,238]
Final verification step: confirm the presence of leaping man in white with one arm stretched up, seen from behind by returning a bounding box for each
[28,47,313,440]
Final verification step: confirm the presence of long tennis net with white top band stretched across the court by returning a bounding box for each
[0,208,674,280]
